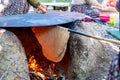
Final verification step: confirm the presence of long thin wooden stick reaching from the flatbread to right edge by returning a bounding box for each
[59,26,120,44]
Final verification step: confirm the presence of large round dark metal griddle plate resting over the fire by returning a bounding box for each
[0,12,85,27]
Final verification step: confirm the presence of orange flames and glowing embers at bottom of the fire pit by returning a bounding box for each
[28,56,65,80]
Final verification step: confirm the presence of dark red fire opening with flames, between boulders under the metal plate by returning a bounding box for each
[6,28,70,80]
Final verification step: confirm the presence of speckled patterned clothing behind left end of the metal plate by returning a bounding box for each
[0,0,29,15]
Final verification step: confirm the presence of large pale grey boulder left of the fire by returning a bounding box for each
[0,29,30,80]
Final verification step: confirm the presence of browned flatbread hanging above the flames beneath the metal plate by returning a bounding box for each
[32,27,69,62]
